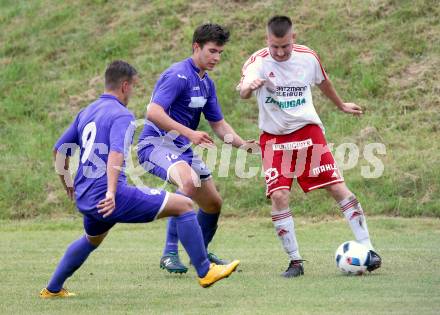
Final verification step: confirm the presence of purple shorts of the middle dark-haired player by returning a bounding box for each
[137,137,211,181]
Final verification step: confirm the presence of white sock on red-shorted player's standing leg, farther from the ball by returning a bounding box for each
[271,208,301,260]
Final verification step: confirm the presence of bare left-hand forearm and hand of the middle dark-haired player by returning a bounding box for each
[147,102,214,145]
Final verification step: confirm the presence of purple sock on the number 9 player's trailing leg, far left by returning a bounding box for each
[47,235,96,293]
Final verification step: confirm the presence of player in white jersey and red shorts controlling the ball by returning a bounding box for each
[238,16,381,278]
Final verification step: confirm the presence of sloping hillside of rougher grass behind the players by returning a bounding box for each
[0,0,440,219]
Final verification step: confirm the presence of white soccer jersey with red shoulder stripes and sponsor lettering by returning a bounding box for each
[240,45,327,135]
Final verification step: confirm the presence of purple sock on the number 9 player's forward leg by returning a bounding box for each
[175,211,209,278]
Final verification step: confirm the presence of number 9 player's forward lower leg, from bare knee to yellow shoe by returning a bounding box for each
[157,194,240,287]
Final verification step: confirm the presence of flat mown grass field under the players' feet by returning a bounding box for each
[0,217,440,315]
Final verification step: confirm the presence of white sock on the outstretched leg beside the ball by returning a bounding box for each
[338,195,373,249]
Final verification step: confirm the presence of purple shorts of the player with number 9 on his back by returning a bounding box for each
[81,184,169,236]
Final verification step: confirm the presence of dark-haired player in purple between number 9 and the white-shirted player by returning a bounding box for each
[138,24,253,273]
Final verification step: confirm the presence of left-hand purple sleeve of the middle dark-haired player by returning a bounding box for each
[151,72,187,111]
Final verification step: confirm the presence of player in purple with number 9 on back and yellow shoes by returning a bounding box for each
[40,61,239,298]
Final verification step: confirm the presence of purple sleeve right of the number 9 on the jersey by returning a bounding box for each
[109,115,134,154]
